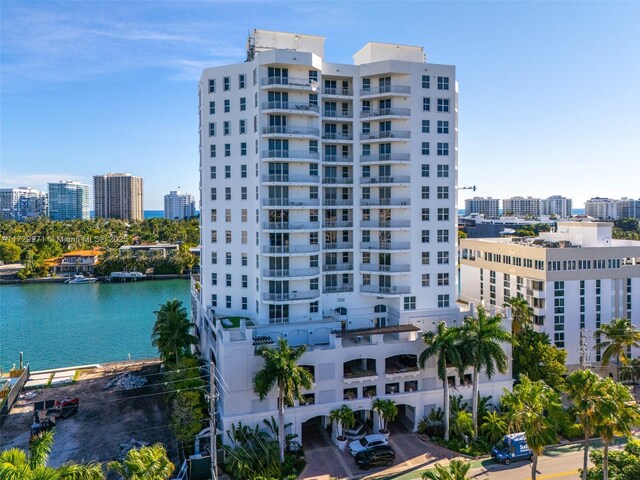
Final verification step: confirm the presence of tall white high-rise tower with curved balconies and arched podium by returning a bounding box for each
[192,31,511,443]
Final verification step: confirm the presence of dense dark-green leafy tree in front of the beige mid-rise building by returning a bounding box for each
[513,329,567,389]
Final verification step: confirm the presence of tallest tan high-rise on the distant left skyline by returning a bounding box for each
[93,173,143,220]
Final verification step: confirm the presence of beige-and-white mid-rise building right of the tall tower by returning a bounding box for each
[460,222,640,368]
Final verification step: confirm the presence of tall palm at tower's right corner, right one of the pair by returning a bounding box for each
[460,307,511,440]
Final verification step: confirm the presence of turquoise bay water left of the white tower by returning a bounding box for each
[0,280,189,370]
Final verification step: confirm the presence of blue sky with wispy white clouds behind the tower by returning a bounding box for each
[0,0,640,209]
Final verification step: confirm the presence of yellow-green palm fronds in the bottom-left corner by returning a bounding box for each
[0,430,104,480]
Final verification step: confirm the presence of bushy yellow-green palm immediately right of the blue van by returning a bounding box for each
[501,375,565,480]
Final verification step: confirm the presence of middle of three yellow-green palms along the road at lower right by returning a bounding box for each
[565,369,604,480]
